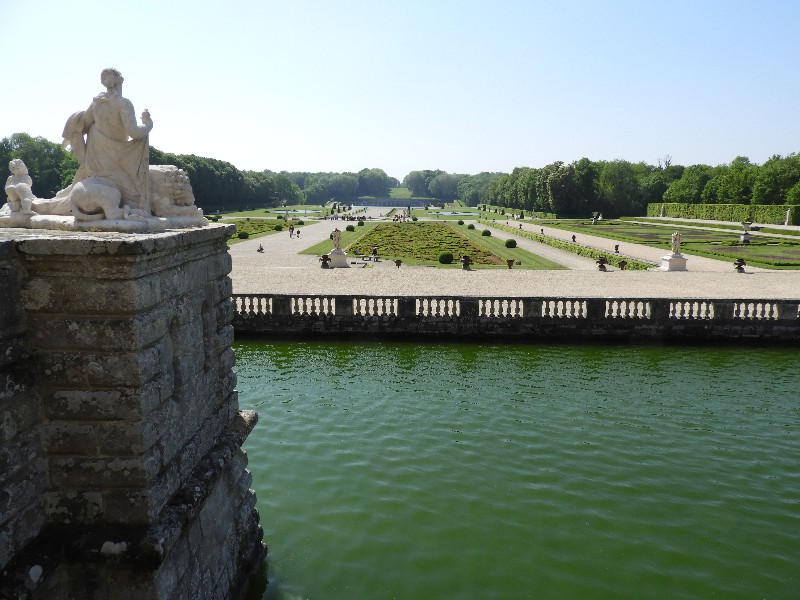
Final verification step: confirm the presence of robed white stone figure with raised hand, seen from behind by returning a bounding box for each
[63,69,153,211]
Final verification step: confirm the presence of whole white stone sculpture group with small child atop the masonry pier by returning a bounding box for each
[0,69,208,232]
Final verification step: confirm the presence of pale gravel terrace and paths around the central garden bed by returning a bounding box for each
[225,216,800,299]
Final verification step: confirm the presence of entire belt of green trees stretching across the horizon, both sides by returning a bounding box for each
[0,133,800,217]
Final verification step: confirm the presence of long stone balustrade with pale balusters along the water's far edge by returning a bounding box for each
[232,294,800,342]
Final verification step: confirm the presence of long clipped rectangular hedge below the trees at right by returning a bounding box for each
[647,202,800,225]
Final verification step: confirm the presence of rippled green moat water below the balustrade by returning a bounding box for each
[235,342,800,600]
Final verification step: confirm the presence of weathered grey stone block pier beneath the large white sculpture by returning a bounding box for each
[0,226,264,600]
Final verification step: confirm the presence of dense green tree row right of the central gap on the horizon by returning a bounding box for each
[404,154,800,216]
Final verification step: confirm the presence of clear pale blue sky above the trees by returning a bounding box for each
[0,0,800,179]
